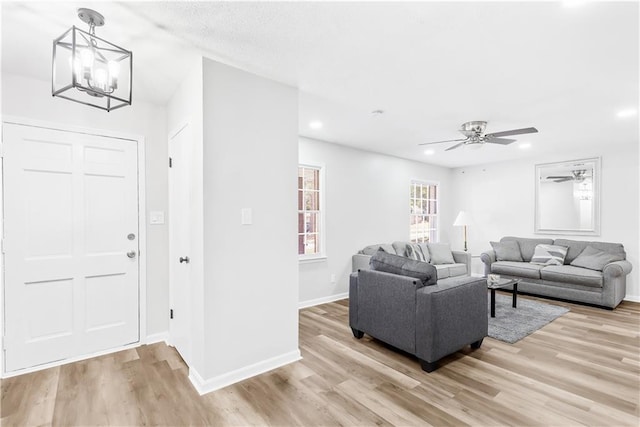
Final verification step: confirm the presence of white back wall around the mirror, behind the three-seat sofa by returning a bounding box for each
[452,142,640,300]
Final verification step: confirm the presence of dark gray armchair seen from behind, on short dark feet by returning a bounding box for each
[349,270,488,372]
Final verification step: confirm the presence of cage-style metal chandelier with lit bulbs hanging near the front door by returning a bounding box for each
[51,8,133,111]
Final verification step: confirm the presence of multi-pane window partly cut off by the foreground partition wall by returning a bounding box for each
[298,166,324,258]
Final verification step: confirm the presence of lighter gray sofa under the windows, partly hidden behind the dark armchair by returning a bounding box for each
[351,241,471,279]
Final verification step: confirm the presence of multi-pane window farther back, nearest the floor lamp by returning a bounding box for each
[409,181,438,243]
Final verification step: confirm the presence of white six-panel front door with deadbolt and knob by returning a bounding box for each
[3,123,139,372]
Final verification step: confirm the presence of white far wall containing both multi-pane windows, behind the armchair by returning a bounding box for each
[299,138,462,306]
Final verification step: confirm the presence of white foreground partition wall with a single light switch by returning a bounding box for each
[199,59,300,390]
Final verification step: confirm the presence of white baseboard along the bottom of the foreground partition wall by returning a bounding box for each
[189,350,302,396]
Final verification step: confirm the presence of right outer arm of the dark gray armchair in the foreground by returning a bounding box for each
[416,276,489,362]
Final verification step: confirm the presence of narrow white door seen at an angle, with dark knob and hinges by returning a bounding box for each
[169,125,193,366]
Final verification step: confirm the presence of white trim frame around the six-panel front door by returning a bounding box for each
[0,115,147,378]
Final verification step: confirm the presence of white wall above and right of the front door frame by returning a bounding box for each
[2,73,169,336]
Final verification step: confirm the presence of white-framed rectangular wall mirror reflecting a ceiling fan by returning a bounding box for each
[535,158,600,235]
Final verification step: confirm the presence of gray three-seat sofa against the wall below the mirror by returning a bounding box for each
[480,236,632,309]
